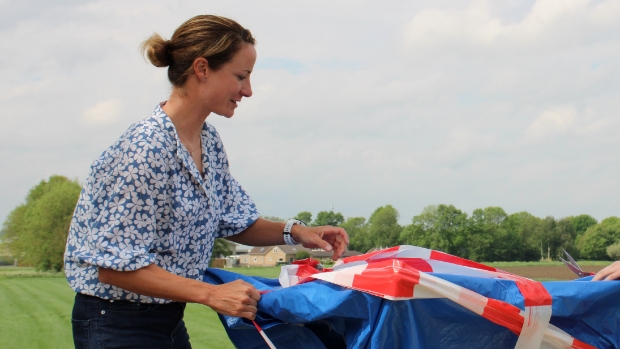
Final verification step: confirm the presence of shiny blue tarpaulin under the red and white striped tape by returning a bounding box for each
[204,269,620,349]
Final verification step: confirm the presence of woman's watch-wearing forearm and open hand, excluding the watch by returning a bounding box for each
[226,218,349,260]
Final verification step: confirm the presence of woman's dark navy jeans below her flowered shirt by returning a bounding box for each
[71,293,192,349]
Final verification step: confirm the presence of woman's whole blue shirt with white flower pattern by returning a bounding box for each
[65,105,259,303]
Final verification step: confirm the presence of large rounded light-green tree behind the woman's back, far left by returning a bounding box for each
[3,176,81,271]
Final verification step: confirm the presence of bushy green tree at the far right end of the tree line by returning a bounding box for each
[580,217,620,260]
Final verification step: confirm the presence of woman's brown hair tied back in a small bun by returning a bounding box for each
[140,15,256,88]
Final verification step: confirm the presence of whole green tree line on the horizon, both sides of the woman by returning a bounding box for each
[0,176,620,270]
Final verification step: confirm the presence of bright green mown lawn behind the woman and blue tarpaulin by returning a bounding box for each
[0,267,280,349]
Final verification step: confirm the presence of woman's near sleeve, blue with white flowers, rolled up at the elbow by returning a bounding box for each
[72,140,157,271]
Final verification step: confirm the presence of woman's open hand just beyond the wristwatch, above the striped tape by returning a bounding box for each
[291,224,349,260]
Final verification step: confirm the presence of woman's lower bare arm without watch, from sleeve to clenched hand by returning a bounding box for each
[99,264,260,320]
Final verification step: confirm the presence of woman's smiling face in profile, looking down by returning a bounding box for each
[203,44,256,118]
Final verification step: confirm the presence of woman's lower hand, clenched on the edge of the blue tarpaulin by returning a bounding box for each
[205,280,260,320]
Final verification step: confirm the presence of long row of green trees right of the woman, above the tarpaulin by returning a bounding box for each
[284,204,620,262]
